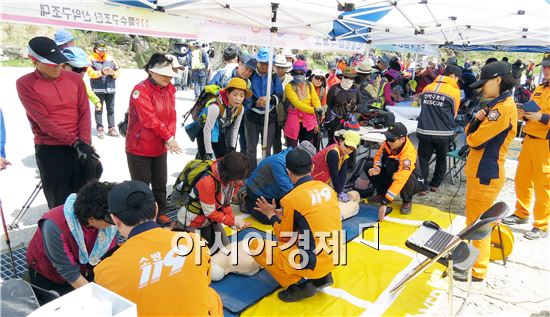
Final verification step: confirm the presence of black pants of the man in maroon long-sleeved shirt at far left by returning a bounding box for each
[34,144,96,209]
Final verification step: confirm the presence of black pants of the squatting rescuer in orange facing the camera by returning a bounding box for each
[365,162,423,203]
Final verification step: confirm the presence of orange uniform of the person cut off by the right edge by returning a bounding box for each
[515,82,550,231]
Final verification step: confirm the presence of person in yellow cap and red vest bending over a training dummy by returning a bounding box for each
[311,130,361,202]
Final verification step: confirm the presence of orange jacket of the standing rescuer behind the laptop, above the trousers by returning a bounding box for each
[465,92,518,180]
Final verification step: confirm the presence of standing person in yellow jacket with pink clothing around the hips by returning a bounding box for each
[284,60,323,148]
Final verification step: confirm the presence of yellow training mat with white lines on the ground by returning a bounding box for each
[231,203,464,316]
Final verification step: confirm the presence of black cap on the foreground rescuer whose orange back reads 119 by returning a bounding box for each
[108,180,155,215]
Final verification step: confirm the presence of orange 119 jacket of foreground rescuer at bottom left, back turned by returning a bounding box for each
[94,222,223,316]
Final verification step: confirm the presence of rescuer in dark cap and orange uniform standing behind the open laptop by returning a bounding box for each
[460,62,520,282]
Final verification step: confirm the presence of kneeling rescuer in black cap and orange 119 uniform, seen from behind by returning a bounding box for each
[250,149,342,302]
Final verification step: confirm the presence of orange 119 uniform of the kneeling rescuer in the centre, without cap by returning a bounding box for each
[250,176,342,288]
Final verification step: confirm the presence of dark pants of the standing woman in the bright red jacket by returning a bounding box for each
[126,153,168,213]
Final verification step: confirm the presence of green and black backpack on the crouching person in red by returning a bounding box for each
[174,160,221,213]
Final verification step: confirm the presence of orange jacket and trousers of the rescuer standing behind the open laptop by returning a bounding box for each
[465,92,518,279]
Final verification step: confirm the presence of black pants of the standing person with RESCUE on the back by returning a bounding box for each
[418,136,451,189]
